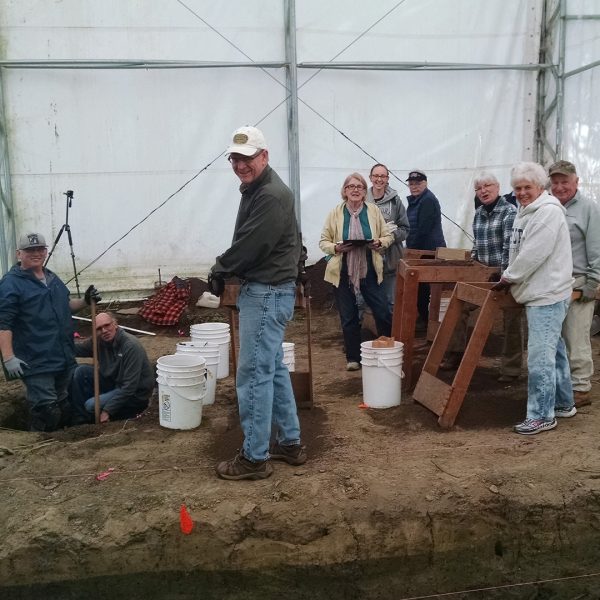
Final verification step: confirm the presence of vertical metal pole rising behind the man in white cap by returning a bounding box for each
[284,0,302,230]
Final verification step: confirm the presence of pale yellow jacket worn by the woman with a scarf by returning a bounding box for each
[319,202,394,287]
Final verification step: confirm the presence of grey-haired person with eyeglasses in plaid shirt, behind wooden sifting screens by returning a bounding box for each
[440,173,523,383]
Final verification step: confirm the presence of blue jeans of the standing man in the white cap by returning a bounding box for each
[236,281,300,462]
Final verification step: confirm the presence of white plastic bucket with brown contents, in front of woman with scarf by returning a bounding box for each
[360,342,403,408]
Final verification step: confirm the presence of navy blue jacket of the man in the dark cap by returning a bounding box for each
[406,188,446,250]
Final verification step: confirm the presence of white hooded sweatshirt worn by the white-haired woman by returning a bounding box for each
[502,192,573,306]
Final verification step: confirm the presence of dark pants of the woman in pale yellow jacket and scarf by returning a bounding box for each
[333,258,392,362]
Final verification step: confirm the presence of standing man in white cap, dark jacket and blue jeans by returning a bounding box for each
[209,127,306,480]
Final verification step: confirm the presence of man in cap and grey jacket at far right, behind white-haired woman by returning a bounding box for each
[548,160,600,407]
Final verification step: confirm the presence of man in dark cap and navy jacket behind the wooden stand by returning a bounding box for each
[406,169,446,328]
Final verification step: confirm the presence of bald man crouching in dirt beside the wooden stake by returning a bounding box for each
[71,312,154,425]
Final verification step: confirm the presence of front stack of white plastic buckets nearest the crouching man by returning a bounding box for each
[156,354,206,429]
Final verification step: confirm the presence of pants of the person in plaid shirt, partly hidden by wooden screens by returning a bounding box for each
[448,304,523,377]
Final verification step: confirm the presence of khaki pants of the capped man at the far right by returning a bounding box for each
[562,277,595,392]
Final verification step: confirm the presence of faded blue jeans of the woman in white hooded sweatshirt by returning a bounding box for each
[526,300,573,421]
